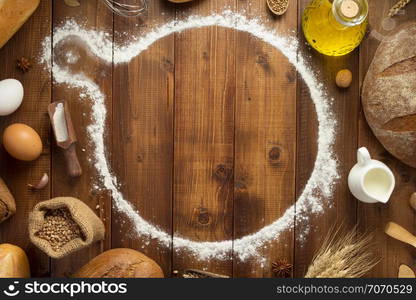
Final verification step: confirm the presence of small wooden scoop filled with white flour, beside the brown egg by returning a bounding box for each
[48,101,82,177]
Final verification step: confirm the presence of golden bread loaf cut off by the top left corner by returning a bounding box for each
[0,0,40,48]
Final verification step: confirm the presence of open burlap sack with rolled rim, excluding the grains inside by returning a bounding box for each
[29,197,105,258]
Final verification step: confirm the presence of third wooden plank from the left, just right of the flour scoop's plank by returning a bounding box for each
[112,1,175,276]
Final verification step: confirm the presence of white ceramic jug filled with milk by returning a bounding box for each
[348,147,395,203]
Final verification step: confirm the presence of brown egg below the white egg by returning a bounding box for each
[3,123,42,161]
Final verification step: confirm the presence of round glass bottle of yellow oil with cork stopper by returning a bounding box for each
[302,0,368,56]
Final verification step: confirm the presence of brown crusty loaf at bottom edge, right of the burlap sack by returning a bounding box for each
[73,248,163,278]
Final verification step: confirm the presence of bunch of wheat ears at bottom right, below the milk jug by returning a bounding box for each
[305,227,379,278]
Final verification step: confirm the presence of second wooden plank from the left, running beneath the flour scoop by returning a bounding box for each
[51,1,113,277]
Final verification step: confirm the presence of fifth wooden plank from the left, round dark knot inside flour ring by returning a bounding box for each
[234,1,297,277]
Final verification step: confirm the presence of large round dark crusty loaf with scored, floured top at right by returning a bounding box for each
[362,23,416,167]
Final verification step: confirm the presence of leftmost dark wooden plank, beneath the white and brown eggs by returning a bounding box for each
[0,1,51,277]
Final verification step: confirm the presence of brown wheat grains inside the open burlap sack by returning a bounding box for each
[35,208,84,251]
